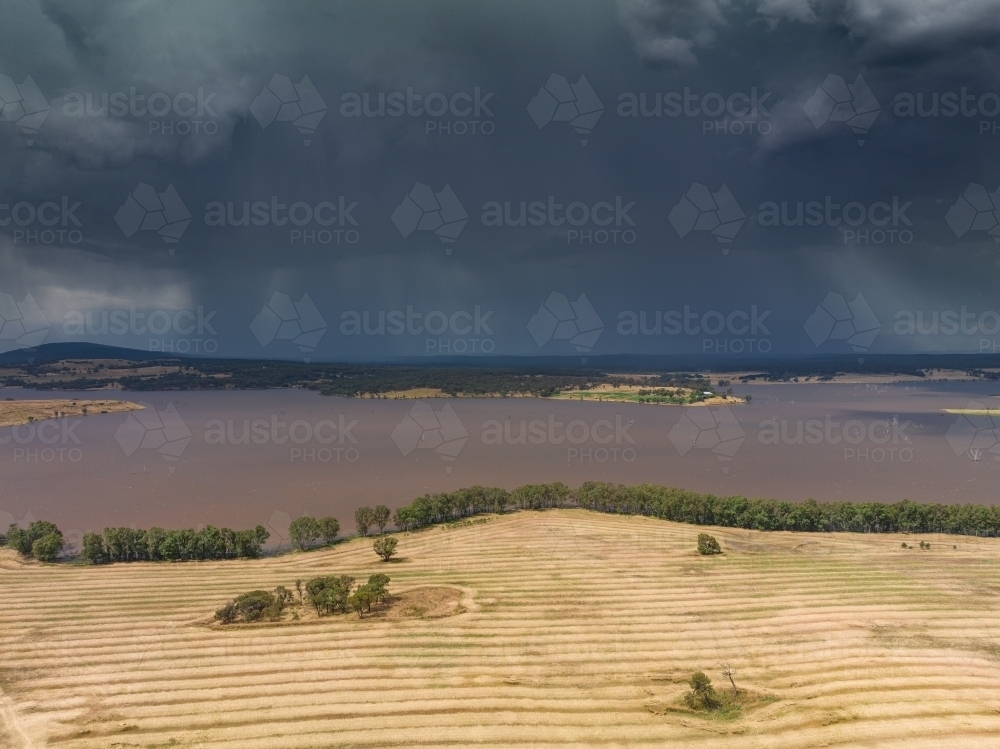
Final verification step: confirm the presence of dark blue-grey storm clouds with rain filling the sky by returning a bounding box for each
[0,0,1000,358]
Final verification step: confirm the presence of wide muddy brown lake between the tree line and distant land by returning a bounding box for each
[0,382,1000,540]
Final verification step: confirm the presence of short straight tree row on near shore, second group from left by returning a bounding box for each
[80,525,271,564]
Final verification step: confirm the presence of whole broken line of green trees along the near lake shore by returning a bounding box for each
[0,481,1000,564]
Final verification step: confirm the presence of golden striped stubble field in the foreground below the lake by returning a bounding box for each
[0,510,1000,749]
